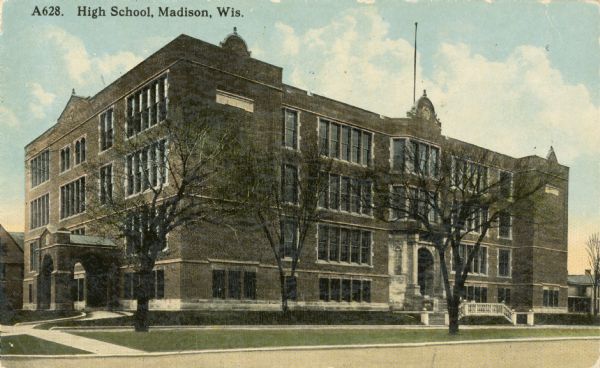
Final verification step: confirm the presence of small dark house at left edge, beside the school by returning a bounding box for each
[0,225,23,309]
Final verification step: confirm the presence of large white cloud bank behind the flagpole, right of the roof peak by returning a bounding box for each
[279,7,600,164]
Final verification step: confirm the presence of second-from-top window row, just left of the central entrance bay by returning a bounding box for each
[319,173,373,215]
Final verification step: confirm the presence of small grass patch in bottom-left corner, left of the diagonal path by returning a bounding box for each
[0,335,89,355]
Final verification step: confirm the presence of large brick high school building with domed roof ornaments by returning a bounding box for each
[23,32,568,311]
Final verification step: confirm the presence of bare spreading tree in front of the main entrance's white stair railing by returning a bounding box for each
[373,140,556,334]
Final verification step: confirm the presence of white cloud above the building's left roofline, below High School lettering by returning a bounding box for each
[45,26,142,86]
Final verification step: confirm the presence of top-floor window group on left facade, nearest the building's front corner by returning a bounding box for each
[127,74,169,137]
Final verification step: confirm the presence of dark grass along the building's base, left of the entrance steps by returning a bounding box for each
[39,311,420,329]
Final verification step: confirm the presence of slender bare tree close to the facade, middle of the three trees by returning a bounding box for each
[227,135,331,313]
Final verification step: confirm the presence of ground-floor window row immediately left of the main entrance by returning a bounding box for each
[319,278,371,303]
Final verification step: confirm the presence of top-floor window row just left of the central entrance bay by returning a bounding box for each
[319,119,373,166]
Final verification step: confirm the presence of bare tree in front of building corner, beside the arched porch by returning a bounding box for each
[87,105,239,331]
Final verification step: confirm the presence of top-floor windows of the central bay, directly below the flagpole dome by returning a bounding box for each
[392,138,440,177]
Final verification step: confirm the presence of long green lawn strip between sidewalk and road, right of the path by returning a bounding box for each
[73,329,600,352]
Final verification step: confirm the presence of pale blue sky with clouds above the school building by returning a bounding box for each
[0,0,600,272]
